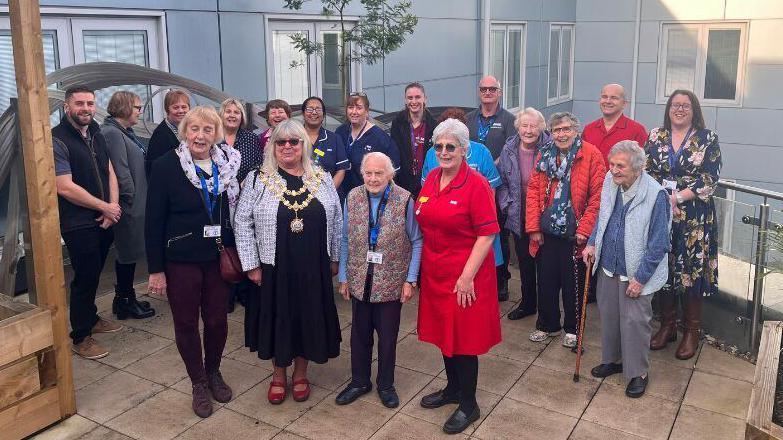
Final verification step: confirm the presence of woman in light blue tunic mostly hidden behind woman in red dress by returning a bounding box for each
[421,107,503,266]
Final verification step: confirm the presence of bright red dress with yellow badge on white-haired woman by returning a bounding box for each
[416,161,500,357]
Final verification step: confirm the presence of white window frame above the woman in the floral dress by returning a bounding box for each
[655,20,748,107]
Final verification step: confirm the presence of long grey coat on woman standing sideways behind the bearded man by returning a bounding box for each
[101,118,147,264]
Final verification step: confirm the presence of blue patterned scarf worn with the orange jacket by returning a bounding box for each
[536,135,582,236]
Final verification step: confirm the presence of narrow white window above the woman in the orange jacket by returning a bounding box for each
[546,23,574,105]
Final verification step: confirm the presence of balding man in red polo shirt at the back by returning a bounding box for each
[582,84,647,170]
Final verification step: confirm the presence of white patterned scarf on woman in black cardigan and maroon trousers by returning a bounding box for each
[174,141,242,219]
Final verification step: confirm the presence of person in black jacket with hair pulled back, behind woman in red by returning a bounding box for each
[390,82,437,197]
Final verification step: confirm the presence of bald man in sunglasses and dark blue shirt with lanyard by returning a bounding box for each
[465,76,517,301]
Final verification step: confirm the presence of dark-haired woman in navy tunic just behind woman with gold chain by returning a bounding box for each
[302,96,351,188]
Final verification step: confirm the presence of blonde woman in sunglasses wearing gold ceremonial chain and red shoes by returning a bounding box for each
[234,119,342,404]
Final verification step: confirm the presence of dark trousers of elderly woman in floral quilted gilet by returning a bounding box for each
[351,297,402,390]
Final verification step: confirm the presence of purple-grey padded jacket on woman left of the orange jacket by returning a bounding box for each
[497,131,552,237]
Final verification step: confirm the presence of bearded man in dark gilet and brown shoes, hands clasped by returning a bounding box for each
[52,86,122,359]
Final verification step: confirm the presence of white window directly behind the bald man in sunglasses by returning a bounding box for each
[489,23,525,109]
